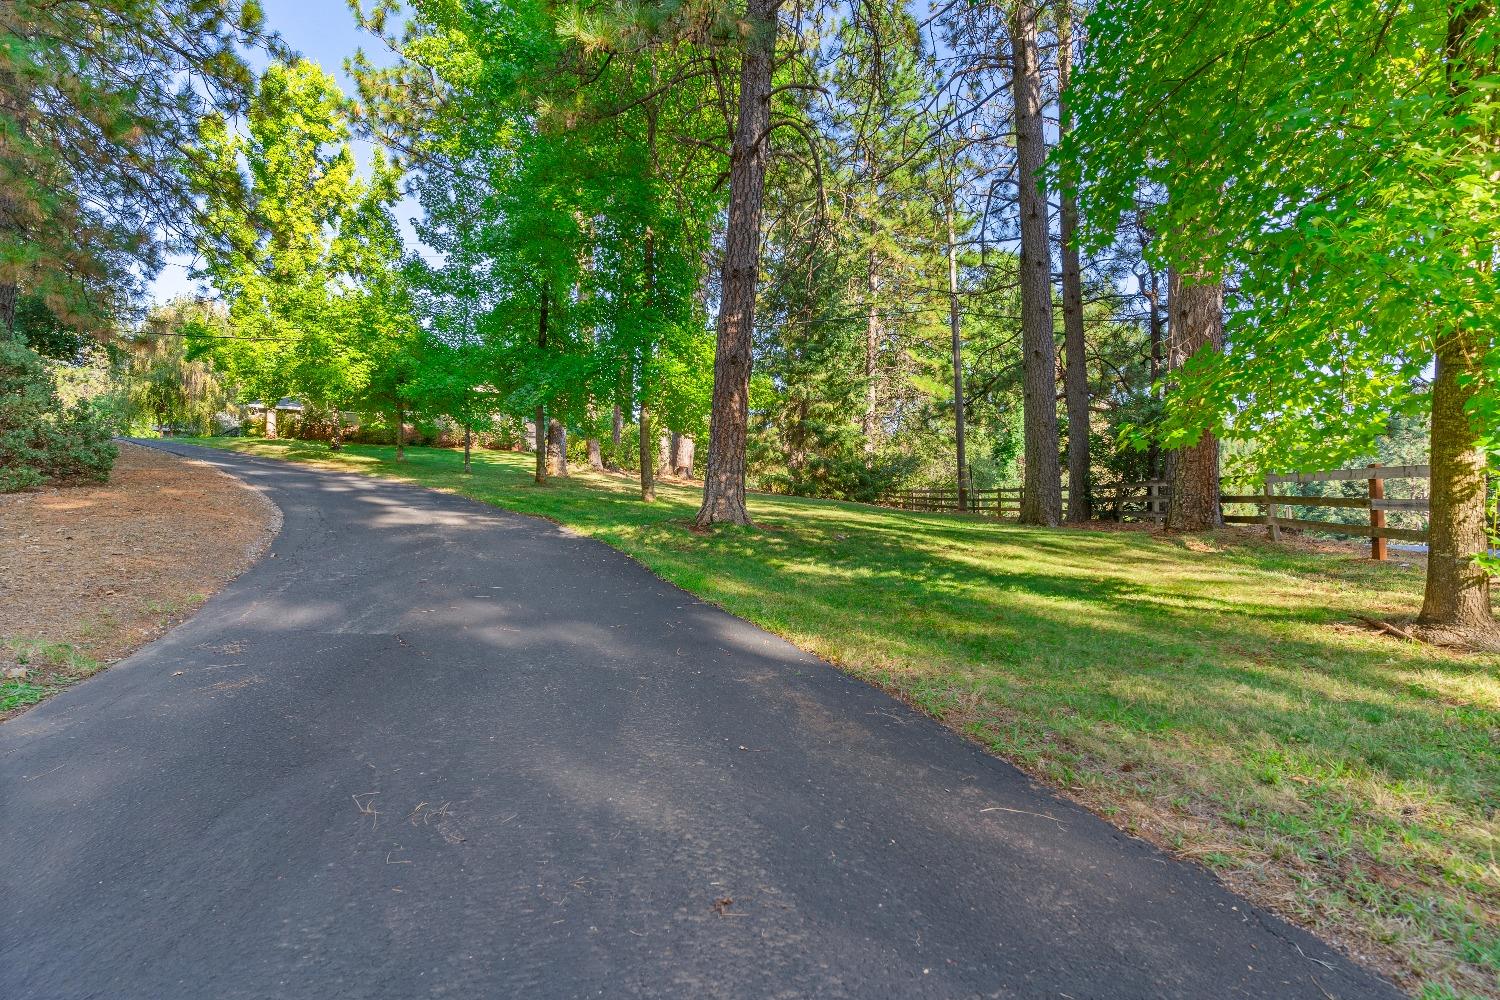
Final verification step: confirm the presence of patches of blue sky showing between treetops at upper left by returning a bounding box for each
[152,0,416,301]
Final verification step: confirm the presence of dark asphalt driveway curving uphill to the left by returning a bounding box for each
[0,445,1400,1000]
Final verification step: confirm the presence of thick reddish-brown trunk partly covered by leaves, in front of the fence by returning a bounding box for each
[1166,270,1224,531]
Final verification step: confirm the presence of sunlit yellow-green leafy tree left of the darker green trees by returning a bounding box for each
[189,60,416,426]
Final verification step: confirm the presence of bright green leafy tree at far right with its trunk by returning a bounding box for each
[1068,0,1500,645]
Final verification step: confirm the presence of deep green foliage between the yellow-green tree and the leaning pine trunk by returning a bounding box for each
[356,3,720,458]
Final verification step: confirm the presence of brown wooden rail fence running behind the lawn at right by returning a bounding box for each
[879,465,1430,559]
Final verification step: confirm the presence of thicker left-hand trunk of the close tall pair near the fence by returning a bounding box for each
[1011,0,1062,525]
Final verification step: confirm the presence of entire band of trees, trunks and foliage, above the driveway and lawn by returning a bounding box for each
[0,0,1500,634]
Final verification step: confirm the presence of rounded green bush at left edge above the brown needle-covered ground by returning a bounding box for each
[0,342,117,493]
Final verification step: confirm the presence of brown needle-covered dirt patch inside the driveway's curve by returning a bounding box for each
[0,444,281,720]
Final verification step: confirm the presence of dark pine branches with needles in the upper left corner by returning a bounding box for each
[0,0,279,338]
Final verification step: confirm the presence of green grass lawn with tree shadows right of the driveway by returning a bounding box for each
[187,439,1500,999]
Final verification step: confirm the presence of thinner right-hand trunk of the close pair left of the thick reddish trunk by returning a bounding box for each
[1058,0,1094,525]
